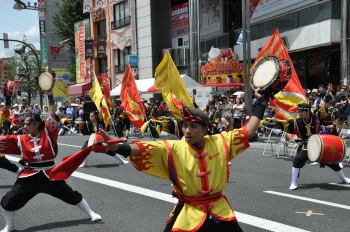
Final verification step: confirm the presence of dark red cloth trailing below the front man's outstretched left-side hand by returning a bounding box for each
[49,146,92,180]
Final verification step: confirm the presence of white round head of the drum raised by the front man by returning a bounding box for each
[251,56,279,89]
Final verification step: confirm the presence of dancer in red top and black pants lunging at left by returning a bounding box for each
[0,92,101,232]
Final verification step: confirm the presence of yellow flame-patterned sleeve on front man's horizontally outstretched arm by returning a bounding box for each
[130,141,170,180]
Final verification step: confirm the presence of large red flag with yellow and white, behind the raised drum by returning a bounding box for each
[253,29,307,120]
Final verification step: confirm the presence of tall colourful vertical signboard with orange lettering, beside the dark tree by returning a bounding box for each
[74,19,90,84]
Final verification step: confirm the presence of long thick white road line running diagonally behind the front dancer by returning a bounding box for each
[6,152,308,232]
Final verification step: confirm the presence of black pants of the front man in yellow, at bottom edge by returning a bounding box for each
[164,204,243,232]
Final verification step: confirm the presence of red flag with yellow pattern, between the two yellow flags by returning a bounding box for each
[120,63,146,129]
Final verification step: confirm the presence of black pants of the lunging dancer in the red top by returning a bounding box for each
[1,171,83,211]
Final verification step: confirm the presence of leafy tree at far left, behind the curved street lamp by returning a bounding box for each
[5,44,39,104]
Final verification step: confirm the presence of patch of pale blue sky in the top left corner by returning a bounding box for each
[0,0,40,58]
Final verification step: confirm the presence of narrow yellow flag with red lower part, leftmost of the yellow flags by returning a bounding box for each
[89,73,111,127]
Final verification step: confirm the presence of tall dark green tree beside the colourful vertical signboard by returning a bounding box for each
[52,0,90,82]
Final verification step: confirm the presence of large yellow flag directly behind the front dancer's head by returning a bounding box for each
[154,51,193,118]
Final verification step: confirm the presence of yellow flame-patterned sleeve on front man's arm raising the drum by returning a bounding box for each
[221,126,250,160]
